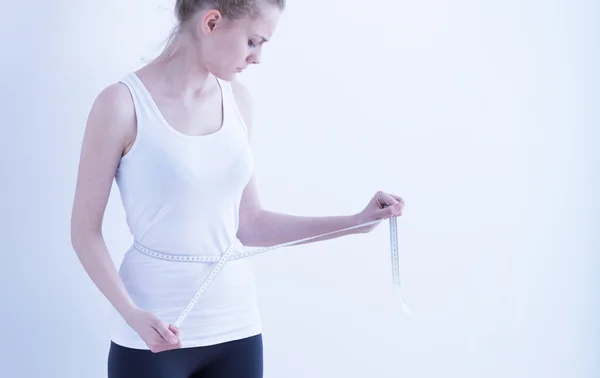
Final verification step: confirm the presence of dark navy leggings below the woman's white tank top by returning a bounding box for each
[108,335,263,378]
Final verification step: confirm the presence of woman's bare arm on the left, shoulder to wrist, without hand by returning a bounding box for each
[71,84,136,320]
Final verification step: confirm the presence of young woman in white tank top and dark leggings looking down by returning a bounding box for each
[71,0,404,378]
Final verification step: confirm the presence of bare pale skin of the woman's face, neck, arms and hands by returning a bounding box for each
[71,6,404,353]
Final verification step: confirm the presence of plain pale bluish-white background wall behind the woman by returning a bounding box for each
[0,0,600,378]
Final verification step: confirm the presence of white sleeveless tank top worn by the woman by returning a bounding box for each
[112,73,261,349]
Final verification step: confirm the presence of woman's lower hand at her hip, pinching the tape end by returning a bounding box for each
[125,308,181,353]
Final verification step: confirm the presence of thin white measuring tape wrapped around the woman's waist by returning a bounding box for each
[133,217,411,328]
